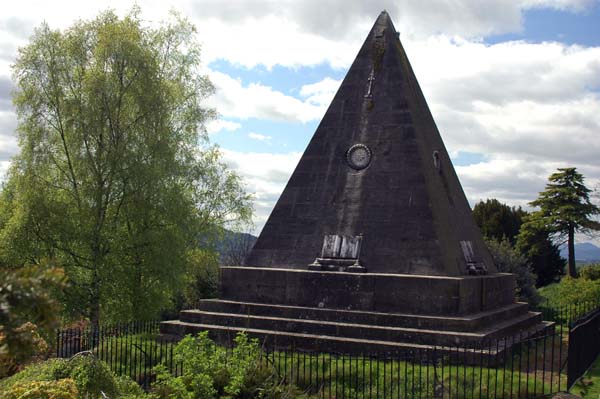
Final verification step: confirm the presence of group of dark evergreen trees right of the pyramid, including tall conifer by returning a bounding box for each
[473,167,600,299]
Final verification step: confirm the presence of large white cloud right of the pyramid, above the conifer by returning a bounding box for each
[398,37,600,173]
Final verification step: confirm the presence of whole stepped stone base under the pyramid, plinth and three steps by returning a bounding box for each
[161,267,553,357]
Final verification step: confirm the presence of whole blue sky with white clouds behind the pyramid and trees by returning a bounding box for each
[0,0,600,244]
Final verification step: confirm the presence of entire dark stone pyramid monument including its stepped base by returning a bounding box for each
[161,11,550,352]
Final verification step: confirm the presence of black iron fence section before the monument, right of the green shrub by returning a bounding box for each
[265,333,566,399]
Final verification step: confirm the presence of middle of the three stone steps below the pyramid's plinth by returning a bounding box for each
[180,310,541,345]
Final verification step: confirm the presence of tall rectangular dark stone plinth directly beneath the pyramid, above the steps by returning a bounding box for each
[221,267,515,316]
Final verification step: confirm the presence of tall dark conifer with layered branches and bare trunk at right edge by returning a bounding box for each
[523,168,600,277]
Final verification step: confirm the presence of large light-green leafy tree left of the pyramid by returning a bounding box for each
[0,8,251,323]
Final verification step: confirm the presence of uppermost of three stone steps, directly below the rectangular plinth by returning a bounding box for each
[193,299,528,332]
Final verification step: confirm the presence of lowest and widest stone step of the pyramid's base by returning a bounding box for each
[161,320,552,364]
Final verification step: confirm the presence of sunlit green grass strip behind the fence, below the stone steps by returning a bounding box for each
[268,346,566,399]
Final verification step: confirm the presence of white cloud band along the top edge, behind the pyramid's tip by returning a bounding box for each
[0,0,594,70]
